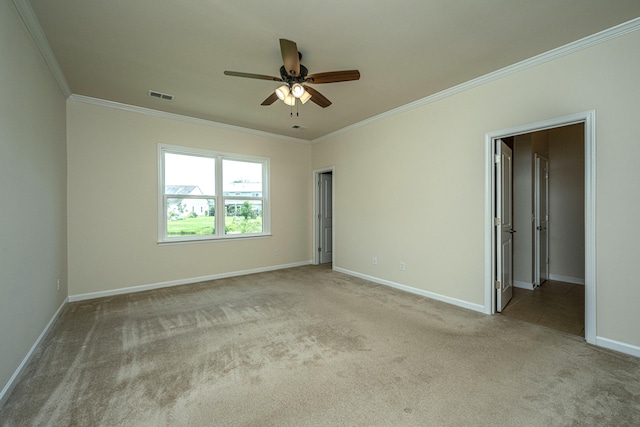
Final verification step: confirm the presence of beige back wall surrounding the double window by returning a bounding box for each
[67,100,312,296]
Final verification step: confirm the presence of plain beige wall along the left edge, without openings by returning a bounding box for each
[0,0,67,406]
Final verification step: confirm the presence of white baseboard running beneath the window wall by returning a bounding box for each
[69,260,311,302]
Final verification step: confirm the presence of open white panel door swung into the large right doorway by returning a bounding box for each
[495,140,515,312]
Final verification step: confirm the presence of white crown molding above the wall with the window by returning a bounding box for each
[68,94,311,144]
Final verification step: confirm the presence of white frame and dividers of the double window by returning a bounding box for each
[158,144,271,243]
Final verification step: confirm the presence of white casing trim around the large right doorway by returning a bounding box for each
[484,110,597,345]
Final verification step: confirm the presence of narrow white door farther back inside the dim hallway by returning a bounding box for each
[534,154,549,286]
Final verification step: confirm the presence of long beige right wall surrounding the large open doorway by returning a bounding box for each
[313,31,640,346]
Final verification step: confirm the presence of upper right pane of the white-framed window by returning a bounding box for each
[222,160,262,197]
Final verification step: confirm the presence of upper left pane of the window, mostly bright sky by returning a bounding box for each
[164,153,216,196]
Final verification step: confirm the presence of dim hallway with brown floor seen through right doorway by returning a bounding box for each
[498,128,584,336]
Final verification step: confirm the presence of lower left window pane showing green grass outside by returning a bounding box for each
[167,197,216,237]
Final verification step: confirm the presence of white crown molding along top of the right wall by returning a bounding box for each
[311,18,640,144]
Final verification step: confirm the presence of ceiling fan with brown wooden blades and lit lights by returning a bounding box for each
[224,39,360,108]
